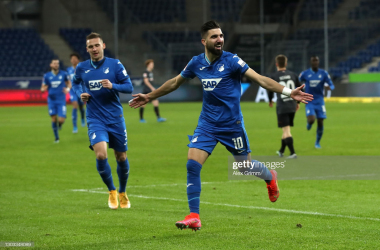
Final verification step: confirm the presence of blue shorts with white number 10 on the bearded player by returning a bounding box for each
[187,127,251,155]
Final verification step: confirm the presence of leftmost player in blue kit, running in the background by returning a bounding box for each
[41,59,71,143]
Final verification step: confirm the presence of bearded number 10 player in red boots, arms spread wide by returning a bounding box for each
[129,21,312,230]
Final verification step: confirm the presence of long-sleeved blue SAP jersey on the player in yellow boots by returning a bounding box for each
[73,57,133,124]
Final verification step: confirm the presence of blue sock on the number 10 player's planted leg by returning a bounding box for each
[186,160,202,214]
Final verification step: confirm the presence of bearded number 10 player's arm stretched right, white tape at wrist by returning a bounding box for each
[245,69,313,103]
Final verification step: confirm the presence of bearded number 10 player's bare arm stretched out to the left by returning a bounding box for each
[129,75,186,108]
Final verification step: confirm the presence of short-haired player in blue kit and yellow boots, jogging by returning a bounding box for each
[73,33,133,209]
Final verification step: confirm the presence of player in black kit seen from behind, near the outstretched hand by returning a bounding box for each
[268,55,301,158]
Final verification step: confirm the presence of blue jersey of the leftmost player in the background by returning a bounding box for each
[42,70,69,104]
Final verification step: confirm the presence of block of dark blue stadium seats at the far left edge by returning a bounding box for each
[0,29,60,77]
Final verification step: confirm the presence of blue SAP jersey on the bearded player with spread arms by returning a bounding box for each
[181,51,249,132]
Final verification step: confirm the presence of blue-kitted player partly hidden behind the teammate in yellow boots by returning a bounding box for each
[67,53,86,133]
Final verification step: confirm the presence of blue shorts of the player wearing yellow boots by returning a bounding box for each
[88,121,128,152]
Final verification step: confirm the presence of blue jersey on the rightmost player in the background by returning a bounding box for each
[299,68,335,105]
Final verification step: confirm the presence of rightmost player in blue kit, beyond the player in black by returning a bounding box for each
[299,56,335,149]
